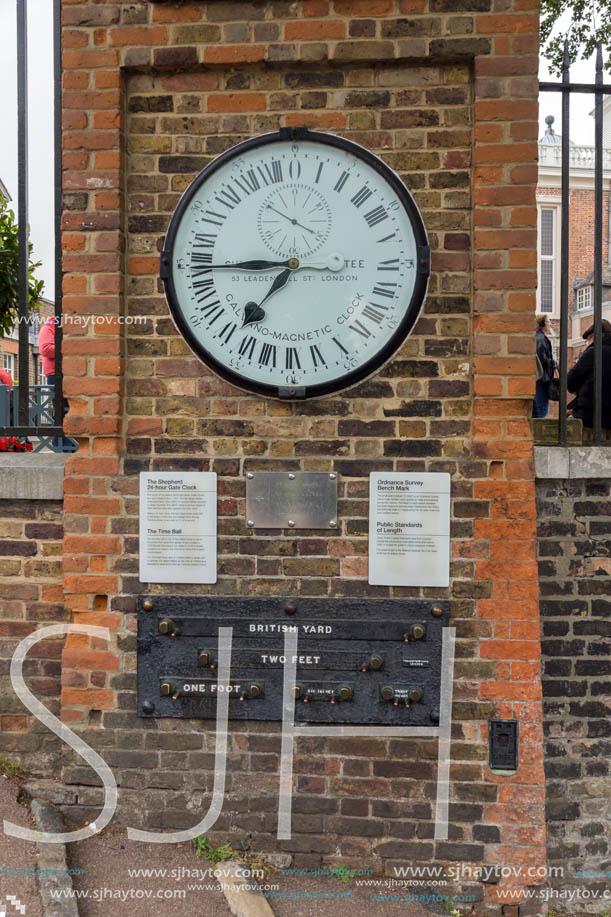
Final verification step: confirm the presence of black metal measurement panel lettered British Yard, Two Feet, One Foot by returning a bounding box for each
[138,596,448,726]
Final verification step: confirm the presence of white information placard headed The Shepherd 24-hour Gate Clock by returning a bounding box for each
[140,471,216,583]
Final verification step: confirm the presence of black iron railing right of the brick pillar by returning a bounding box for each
[539,40,611,446]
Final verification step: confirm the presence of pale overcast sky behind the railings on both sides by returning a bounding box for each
[0,0,594,299]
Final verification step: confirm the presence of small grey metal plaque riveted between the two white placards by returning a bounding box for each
[246,471,337,529]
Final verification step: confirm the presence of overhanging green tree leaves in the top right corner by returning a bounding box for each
[541,0,611,75]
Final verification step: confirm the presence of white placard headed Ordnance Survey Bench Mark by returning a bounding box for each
[369,471,450,586]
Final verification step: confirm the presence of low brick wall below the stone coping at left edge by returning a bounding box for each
[0,500,64,775]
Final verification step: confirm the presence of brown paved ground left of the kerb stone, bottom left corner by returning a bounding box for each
[0,775,42,917]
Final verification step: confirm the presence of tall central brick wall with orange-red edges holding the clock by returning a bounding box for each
[57,0,545,900]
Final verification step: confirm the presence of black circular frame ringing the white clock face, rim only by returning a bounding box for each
[160,127,431,400]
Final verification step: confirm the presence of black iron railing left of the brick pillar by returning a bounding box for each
[0,0,64,451]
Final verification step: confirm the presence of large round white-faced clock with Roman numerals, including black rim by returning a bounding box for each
[161,128,430,398]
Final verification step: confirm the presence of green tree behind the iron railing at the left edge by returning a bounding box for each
[0,194,44,337]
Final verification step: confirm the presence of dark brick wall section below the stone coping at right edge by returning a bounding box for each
[537,479,611,914]
